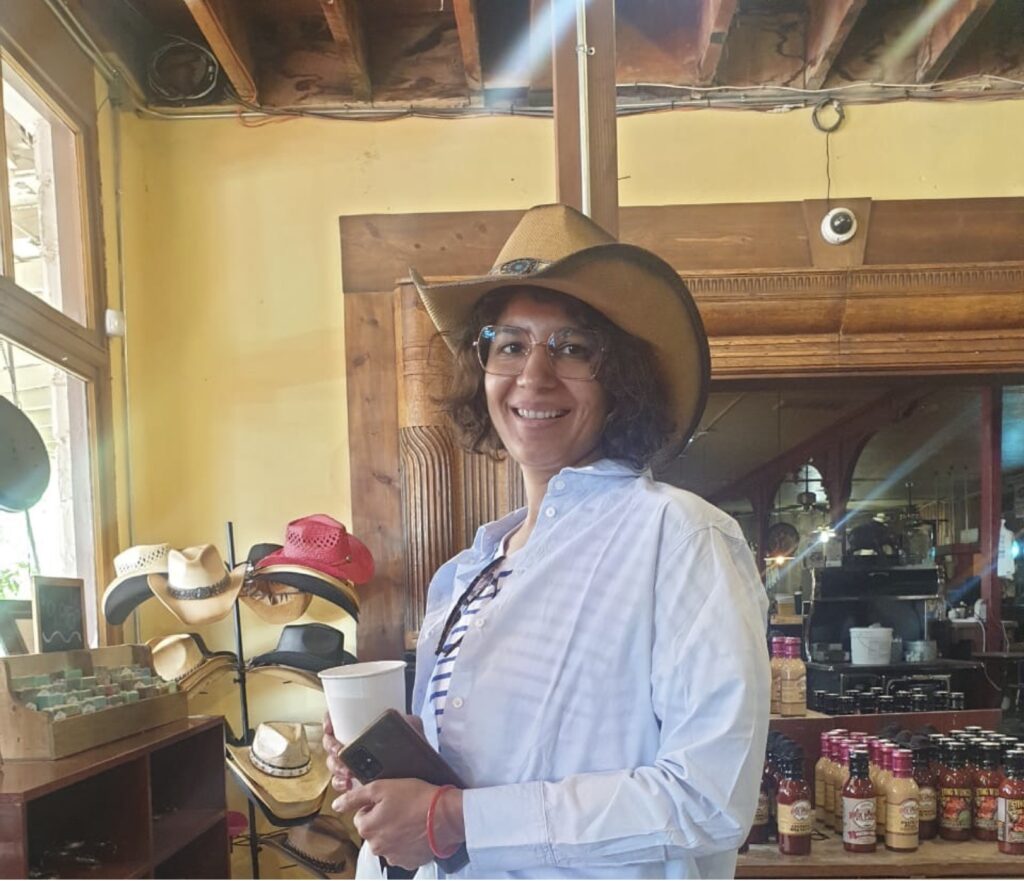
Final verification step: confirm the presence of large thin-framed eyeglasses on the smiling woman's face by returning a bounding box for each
[473,325,605,380]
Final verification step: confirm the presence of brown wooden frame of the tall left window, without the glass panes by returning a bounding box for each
[0,13,122,645]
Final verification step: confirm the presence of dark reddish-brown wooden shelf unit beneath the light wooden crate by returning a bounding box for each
[0,716,229,878]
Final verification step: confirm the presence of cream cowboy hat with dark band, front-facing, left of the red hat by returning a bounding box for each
[146,545,243,625]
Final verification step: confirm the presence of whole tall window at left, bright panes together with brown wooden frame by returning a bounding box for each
[0,48,114,645]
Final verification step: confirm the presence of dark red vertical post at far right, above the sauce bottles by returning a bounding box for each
[978,385,1002,652]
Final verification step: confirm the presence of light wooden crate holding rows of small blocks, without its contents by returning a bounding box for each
[0,645,188,760]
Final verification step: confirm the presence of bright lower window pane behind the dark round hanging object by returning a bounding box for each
[0,337,96,645]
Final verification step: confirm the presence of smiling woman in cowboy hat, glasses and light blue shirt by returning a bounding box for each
[326,205,770,878]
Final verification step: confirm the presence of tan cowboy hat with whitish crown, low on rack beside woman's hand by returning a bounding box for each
[227,722,331,820]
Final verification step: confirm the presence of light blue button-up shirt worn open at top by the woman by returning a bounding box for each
[413,460,770,878]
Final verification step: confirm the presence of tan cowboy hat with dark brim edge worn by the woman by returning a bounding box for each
[410,205,711,456]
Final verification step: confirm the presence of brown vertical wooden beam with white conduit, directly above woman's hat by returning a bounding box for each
[552,0,618,236]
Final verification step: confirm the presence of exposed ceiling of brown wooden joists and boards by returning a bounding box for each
[70,0,1024,112]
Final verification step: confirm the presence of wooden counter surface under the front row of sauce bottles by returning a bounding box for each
[736,830,1024,878]
